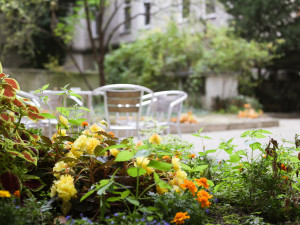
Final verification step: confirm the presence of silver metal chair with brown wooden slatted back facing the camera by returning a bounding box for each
[93,84,153,137]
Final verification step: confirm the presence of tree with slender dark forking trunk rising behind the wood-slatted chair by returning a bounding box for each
[0,0,201,89]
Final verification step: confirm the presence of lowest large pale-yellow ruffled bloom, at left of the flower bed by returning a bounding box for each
[51,174,77,202]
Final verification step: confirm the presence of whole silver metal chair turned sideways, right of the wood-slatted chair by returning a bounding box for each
[142,90,188,136]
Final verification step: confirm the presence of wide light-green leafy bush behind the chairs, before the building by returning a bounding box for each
[105,22,275,94]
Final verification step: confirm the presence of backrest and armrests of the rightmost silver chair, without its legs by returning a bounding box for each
[143,90,187,123]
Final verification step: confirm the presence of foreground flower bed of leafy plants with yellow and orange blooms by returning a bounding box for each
[0,71,300,225]
